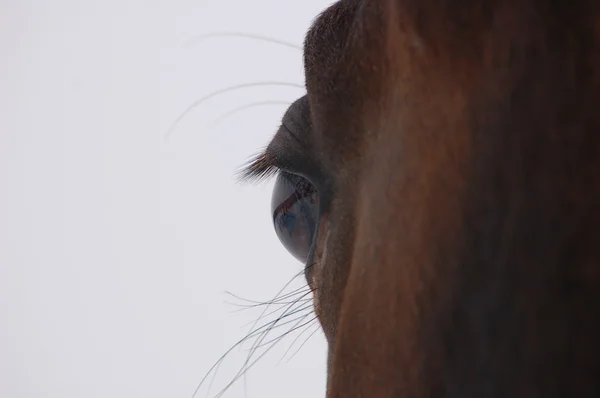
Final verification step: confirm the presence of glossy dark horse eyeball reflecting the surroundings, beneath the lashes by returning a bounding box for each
[271,172,318,263]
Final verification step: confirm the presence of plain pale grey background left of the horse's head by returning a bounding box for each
[0,0,331,398]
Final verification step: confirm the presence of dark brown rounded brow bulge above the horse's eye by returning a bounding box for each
[304,0,388,144]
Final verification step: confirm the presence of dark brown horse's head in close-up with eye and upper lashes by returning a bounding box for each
[245,0,600,398]
